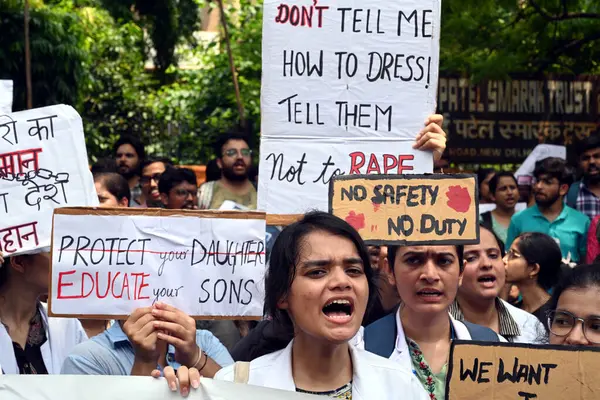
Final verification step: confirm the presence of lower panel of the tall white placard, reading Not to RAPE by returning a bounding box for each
[258,138,433,214]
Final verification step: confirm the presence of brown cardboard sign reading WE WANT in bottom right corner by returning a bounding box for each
[446,341,600,400]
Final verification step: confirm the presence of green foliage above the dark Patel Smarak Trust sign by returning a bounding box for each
[440,0,600,79]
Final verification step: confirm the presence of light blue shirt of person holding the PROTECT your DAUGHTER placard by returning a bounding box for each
[61,323,233,375]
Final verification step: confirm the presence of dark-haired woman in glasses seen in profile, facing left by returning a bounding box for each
[504,232,562,331]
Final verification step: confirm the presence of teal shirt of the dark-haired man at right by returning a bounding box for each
[506,204,590,263]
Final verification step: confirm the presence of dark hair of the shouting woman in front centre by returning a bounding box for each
[264,212,379,329]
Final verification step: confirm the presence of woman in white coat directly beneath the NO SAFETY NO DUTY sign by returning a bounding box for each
[364,246,502,400]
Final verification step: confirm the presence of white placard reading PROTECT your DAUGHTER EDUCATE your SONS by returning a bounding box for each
[49,208,266,319]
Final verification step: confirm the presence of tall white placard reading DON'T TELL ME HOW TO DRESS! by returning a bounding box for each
[258,0,440,220]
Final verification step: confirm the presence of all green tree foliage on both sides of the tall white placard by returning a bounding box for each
[0,0,600,163]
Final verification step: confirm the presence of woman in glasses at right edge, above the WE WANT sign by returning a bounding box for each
[548,264,600,346]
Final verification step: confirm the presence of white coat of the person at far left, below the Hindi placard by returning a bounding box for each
[0,304,88,374]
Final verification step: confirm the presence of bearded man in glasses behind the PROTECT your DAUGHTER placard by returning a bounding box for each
[198,133,257,210]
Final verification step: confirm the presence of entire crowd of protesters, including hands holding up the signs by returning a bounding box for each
[0,116,600,399]
